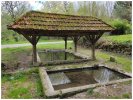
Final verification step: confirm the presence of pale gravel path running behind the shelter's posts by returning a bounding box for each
[1,41,72,48]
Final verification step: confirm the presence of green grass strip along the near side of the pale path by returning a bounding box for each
[1,43,73,62]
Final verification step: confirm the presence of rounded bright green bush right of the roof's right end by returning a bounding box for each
[111,19,132,35]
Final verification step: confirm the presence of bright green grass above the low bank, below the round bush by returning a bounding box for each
[103,34,132,43]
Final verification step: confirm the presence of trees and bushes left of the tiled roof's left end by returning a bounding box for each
[1,1,31,41]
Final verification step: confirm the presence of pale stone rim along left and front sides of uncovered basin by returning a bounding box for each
[39,67,132,98]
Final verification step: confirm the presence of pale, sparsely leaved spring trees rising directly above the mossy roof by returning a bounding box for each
[39,1,113,21]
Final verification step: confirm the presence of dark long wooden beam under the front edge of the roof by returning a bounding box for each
[14,29,108,37]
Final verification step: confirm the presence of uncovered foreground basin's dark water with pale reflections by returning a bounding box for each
[48,67,130,90]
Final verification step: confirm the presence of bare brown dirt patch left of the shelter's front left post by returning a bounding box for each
[3,52,32,73]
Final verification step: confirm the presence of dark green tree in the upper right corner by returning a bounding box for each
[113,1,132,21]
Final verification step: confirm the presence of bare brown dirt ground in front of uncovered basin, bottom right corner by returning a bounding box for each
[66,82,132,99]
